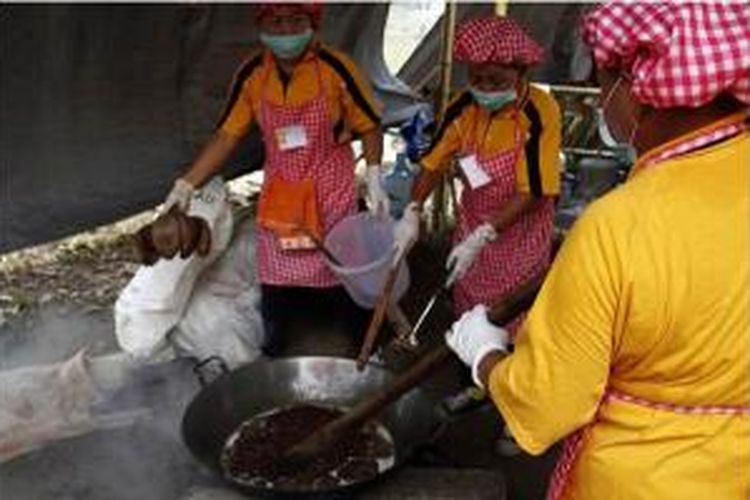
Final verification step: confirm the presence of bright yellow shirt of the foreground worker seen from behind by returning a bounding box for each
[489,121,750,500]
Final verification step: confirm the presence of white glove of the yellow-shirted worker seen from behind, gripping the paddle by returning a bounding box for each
[445,304,509,389]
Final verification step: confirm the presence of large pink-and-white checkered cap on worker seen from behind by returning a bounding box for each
[583,0,750,108]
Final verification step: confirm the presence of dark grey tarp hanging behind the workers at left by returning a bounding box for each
[0,4,588,252]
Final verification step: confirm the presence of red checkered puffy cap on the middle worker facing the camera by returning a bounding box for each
[453,16,544,66]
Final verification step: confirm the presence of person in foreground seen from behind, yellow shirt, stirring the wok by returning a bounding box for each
[446,2,750,500]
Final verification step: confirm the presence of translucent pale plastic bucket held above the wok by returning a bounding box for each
[324,212,409,309]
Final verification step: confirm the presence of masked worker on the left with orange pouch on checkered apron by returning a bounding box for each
[164,2,387,356]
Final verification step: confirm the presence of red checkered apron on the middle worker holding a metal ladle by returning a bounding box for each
[453,113,555,333]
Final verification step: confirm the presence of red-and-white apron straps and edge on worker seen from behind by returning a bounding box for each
[547,120,750,500]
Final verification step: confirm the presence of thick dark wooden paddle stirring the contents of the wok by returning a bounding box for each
[284,278,542,462]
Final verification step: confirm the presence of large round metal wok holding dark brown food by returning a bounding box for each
[182,357,439,494]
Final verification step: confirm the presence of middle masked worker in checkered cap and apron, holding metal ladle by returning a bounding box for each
[395,16,560,329]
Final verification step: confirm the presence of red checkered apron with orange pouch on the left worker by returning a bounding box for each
[257,61,357,288]
